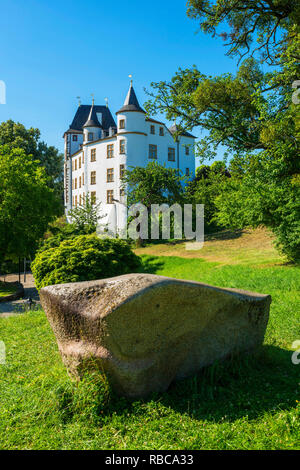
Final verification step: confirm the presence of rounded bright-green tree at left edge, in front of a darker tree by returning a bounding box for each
[0,145,59,260]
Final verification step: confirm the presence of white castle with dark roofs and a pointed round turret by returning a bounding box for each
[64,81,195,234]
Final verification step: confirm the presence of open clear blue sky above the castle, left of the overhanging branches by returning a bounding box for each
[0,0,236,150]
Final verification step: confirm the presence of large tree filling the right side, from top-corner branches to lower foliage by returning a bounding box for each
[146,0,300,260]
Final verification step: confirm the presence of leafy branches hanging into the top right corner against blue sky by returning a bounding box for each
[187,0,300,65]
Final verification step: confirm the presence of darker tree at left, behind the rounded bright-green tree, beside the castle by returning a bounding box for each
[0,119,63,200]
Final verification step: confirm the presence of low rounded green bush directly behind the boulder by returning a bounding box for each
[32,234,141,289]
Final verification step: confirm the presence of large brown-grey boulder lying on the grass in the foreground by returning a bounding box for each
[40,274,271,397]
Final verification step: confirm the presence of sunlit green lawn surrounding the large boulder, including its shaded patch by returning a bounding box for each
[0,256,300,450]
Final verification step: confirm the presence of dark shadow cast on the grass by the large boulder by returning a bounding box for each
[105,346,299,422]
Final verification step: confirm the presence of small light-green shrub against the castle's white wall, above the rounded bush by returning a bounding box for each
[68,193,105,234]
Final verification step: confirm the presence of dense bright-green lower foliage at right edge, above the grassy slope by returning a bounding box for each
[215,151,300,262]
